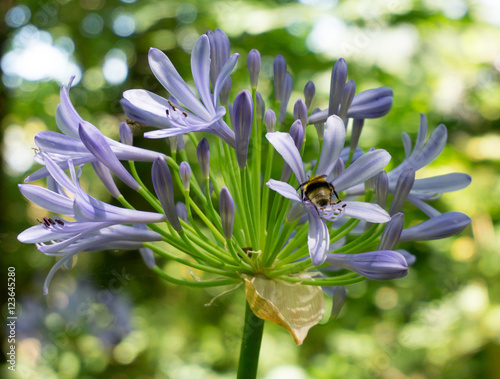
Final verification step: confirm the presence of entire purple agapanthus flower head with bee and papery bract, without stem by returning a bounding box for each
[19,30,470,343]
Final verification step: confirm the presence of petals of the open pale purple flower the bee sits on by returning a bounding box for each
[266,116,390,265]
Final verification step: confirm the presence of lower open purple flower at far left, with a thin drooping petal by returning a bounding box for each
[18,158,165,294]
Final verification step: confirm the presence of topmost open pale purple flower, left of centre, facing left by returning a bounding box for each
[121,35,238,147]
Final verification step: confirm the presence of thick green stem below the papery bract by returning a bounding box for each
[237,302,264,379]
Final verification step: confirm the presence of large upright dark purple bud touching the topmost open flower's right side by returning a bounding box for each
[233,90,253,169]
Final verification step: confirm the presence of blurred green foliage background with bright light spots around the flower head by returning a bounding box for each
[0,0,500,379]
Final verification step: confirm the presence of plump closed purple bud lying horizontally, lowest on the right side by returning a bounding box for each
[326,250,408,280]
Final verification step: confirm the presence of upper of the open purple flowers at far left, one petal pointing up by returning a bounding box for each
[25,78,165,182]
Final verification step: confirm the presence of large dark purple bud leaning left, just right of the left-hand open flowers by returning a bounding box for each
[151,157,182,231]
